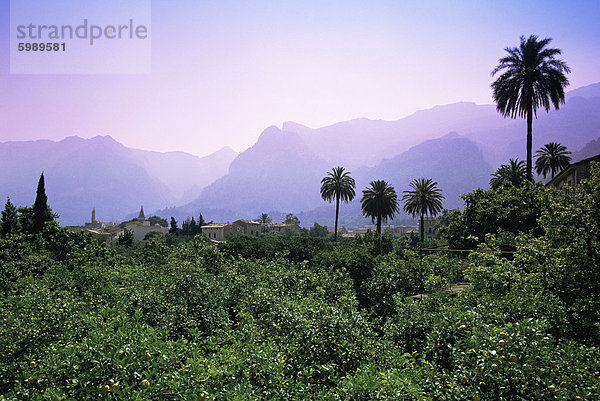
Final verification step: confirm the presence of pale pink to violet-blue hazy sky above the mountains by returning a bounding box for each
[0,0,600,156]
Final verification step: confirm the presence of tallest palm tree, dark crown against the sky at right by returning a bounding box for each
[492,35,571,181]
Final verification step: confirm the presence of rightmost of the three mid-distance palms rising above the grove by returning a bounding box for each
[402,178,444,242]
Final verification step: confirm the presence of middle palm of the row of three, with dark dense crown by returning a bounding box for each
[360,180,400,234]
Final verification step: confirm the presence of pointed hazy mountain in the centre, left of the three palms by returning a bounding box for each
[164,127,328,220]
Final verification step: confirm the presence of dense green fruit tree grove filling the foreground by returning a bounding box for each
[0,176,600,401]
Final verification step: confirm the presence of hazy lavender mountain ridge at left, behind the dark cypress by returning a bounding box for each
[0,136,235,225]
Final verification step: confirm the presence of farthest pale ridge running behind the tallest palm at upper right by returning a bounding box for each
[283,83,600,169]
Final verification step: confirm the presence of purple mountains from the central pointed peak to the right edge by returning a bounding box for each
[161,85,600,225]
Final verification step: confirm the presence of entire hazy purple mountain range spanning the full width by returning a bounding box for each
[0,83,600,226]
